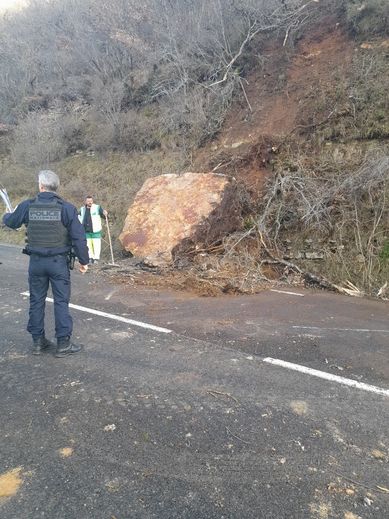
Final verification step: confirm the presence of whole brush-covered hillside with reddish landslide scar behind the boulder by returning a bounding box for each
[0,0,389,297]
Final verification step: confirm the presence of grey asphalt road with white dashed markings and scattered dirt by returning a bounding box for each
[0,246,389,519]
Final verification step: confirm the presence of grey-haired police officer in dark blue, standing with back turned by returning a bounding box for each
[3,170,89,357]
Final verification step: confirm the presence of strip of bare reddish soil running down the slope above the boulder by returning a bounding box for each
[194,19,354,201]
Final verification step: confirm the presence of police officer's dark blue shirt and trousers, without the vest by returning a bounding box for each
[3,191,89,339]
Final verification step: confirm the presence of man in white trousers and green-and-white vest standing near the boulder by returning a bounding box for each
[78,195,108,263]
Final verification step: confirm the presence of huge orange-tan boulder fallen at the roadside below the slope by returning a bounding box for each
[119,173,241,265]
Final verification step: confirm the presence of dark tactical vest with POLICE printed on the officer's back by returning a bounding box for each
[27,198,70,250]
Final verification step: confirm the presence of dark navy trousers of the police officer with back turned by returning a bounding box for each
[27,254,73,338]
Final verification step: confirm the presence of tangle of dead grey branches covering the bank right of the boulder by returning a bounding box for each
[257,152,389,297]
